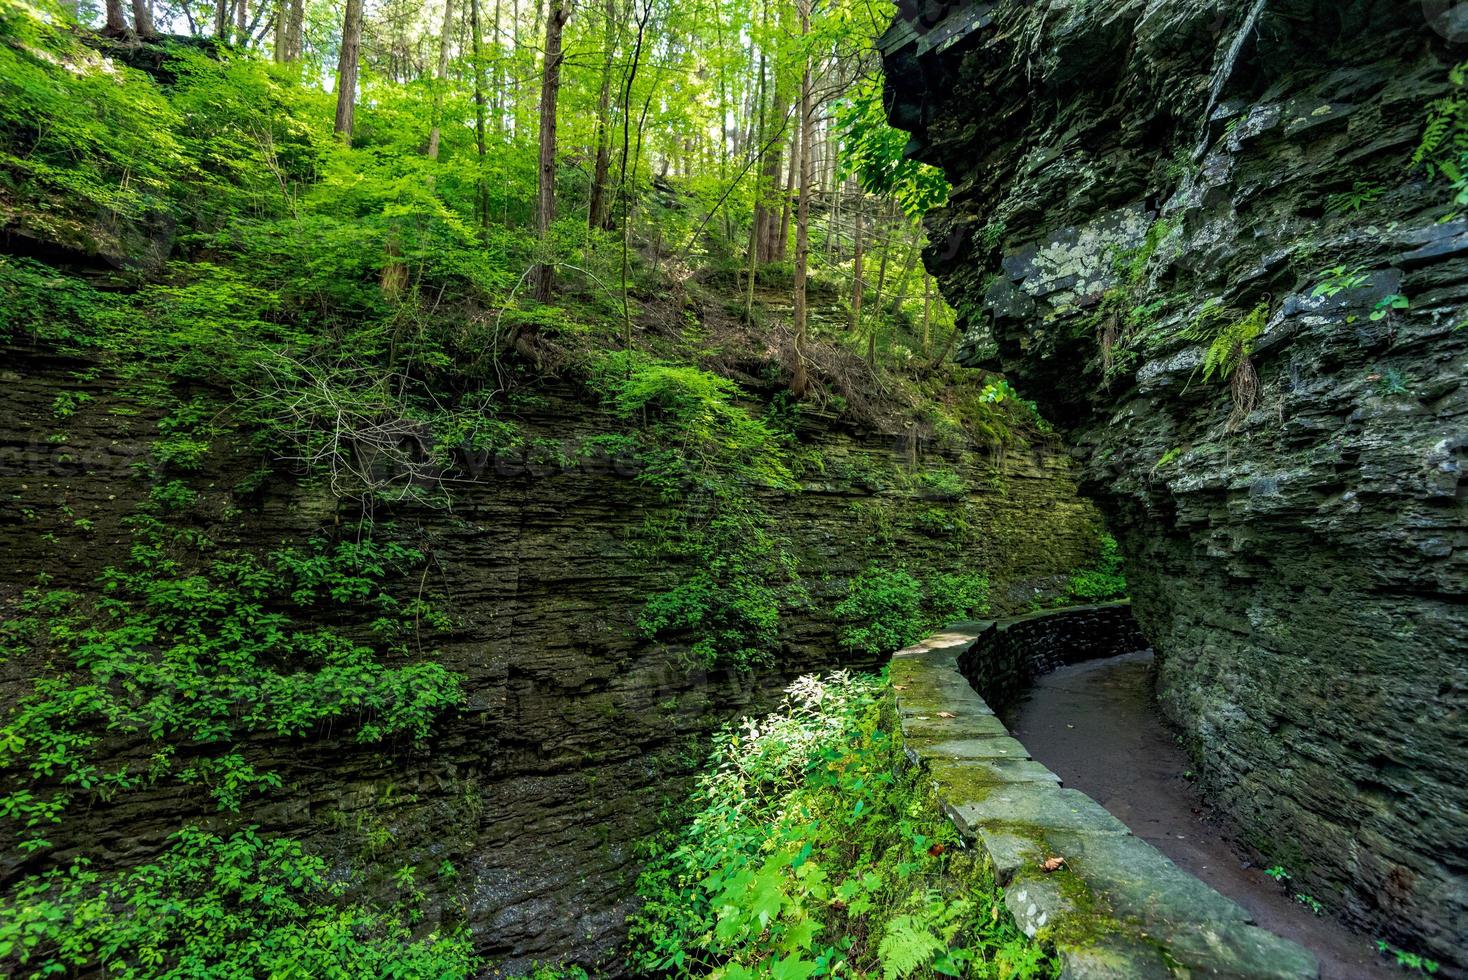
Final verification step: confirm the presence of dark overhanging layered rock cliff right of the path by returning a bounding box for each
[882,0,1468,968]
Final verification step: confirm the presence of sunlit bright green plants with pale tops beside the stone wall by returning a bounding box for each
[630,673,1054,980]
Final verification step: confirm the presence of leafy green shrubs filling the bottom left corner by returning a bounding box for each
[0,826,477,980]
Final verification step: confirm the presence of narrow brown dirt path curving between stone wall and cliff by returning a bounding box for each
[1004,653,1403,980]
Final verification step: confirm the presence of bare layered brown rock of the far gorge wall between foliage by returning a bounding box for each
[0,349,1095,977]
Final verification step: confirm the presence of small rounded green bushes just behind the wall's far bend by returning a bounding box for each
[832,565,989,656]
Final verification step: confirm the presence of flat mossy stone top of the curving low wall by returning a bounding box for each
[891,610,1320,980]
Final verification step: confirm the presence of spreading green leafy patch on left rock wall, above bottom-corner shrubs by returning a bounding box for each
[0,513,461,849]
